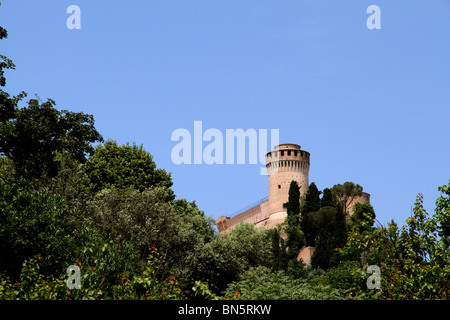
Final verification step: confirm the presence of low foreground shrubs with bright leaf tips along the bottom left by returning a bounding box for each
[0,247,184,300]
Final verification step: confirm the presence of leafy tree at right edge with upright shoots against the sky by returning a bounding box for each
[340,184,450,299]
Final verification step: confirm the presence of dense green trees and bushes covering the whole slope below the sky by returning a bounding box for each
[0,13,450,299]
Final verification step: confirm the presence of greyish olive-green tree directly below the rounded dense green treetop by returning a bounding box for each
[86,187,181,264]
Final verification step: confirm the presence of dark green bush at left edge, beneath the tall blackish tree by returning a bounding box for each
[0,178,73,279]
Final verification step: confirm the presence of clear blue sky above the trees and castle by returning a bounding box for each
[0,0,450,228]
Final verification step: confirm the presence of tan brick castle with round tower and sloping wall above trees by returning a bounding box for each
[216,143,370,236]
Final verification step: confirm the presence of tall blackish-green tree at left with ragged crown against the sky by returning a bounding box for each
[0,91,103,179]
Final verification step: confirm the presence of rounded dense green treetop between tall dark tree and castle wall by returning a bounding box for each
[85,139,175,201]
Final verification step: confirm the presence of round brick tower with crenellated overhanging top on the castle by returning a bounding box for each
[266,143,310,214]
